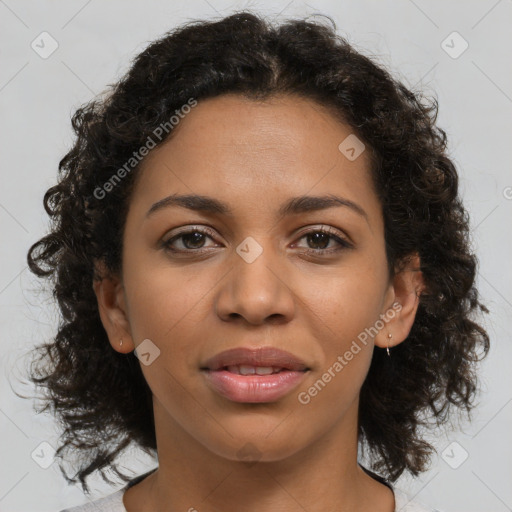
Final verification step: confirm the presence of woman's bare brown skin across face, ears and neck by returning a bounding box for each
[94,95,423,512]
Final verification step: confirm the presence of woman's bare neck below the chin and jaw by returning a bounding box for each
[123,399,394,512]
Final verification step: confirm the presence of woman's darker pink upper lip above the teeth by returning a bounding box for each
[202,347,309,371]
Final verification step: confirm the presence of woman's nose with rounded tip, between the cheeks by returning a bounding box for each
[216,242,296,325]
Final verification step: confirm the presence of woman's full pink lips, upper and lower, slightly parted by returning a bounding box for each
[201,347,309,403]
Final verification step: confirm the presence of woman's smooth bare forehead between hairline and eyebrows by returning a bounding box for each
[127,94,376,224]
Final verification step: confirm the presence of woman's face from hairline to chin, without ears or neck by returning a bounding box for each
[103,95,396,461]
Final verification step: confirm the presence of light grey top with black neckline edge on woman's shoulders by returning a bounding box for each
[60,468,440,512]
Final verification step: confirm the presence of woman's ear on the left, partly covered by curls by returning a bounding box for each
[92,262,135,354]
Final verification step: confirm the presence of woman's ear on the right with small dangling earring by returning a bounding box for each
[374,253,426,348]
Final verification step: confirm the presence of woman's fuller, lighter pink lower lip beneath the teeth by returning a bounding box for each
[203,370,307,403]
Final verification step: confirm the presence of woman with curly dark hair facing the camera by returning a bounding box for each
[28,12,489,512]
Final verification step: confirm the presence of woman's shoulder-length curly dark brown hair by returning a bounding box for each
[22,12,489,492]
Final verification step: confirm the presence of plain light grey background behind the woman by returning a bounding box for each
[0,0,512,512]
